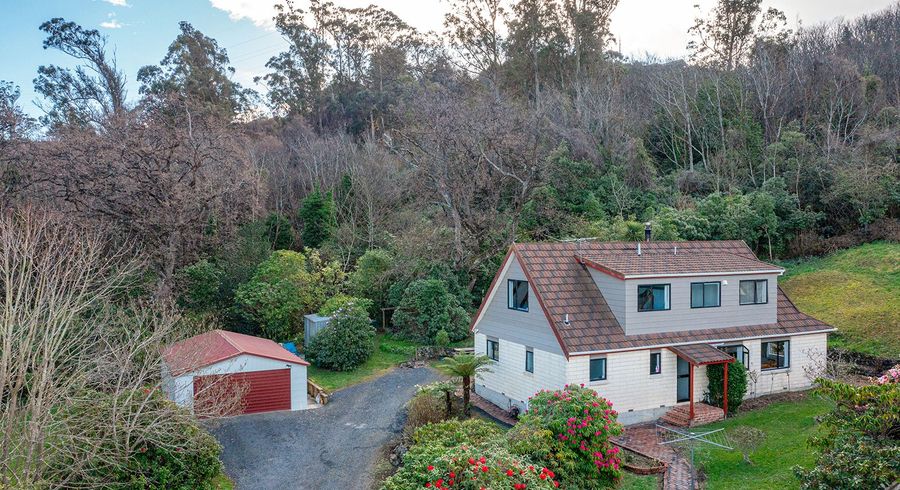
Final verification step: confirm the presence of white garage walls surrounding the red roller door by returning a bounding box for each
[163,354,307,410]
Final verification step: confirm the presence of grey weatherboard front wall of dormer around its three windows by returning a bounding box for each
[624,274,778,335]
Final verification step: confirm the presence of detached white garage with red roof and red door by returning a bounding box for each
[162,330,309,416]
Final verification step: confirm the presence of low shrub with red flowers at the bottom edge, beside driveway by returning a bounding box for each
[383,420,559,490]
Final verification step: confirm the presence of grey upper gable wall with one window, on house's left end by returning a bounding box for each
[475,254,562,356]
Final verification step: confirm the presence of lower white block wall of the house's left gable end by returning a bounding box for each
[475,334,566,410]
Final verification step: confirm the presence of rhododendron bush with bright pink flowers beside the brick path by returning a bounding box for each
[510,385,622,488]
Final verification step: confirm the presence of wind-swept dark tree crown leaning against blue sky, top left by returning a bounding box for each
[34,17,127,128]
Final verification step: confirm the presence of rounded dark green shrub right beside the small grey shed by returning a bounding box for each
[306,305,375,371]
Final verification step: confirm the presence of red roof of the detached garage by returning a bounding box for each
[163,329,309,376]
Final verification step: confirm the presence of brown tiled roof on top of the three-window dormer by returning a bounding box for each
[579,251,784,279]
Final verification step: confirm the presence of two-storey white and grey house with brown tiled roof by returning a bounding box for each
[472,238,835,424]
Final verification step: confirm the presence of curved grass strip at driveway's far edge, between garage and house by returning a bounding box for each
[308,334,416,391]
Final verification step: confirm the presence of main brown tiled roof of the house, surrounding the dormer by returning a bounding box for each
[512,240,833,355]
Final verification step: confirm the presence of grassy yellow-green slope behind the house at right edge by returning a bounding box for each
[779,242,900,359]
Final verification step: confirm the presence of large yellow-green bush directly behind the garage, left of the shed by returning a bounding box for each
[235,250,344,341]
